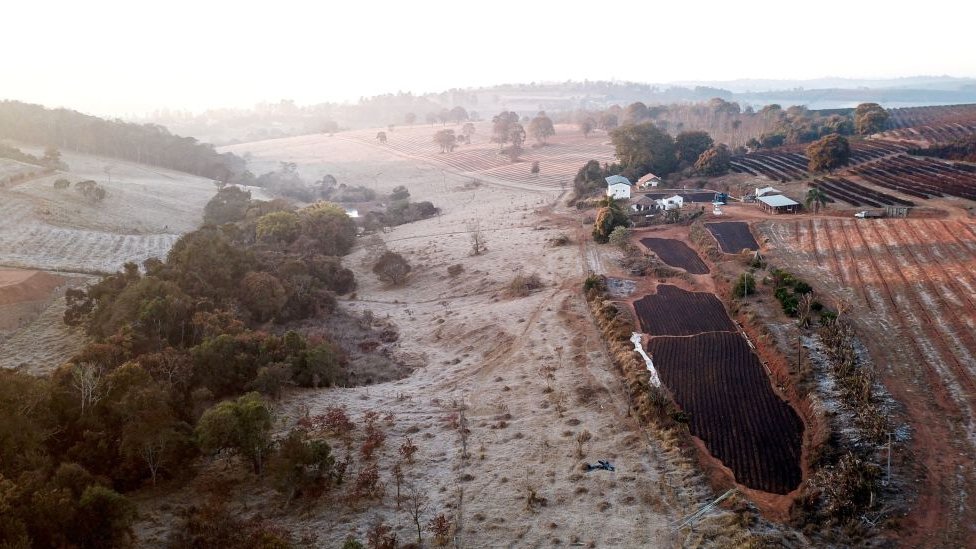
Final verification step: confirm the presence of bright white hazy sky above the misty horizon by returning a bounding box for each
[0,0,976,115]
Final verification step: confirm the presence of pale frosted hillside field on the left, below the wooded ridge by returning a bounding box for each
[0,148,215,272]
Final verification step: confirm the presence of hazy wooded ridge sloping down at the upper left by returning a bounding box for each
[0,101,247,182]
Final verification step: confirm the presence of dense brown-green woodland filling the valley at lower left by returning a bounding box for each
[0,193,370,547]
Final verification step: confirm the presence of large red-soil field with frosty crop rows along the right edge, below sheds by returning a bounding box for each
[762,218,976,540]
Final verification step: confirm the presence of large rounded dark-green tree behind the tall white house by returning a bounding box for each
[610,122,676,176]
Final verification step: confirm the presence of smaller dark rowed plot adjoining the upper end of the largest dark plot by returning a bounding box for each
[634,285,736,336]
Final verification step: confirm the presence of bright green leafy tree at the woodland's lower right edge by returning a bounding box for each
[196,393,272,474]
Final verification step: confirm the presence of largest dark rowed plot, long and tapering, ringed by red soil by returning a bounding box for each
[647,332,803,494]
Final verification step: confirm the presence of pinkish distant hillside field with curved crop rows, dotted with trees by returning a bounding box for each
[335,122,614,188]
